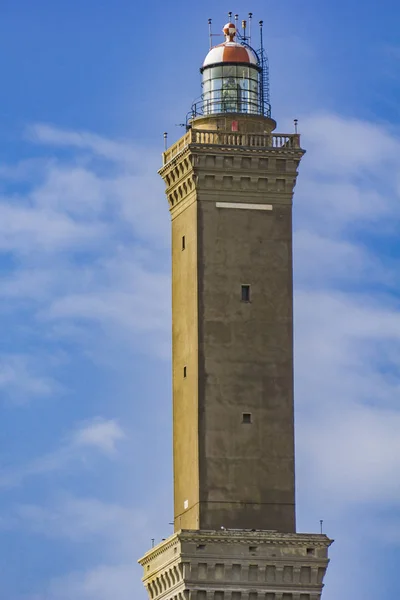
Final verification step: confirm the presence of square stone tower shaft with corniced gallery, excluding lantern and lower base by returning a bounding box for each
[160,114,304,532]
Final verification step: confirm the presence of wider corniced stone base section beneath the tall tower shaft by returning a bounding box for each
[139,530,332,600]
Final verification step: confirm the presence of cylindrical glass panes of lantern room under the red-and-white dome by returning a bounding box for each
[202,64,261,115]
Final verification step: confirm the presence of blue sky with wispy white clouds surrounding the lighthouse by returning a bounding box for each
[0,0,400,600]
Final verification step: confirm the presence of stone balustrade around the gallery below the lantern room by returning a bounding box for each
[163,129,300,165]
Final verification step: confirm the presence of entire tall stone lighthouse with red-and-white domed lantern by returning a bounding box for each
[140,16,331,600]
